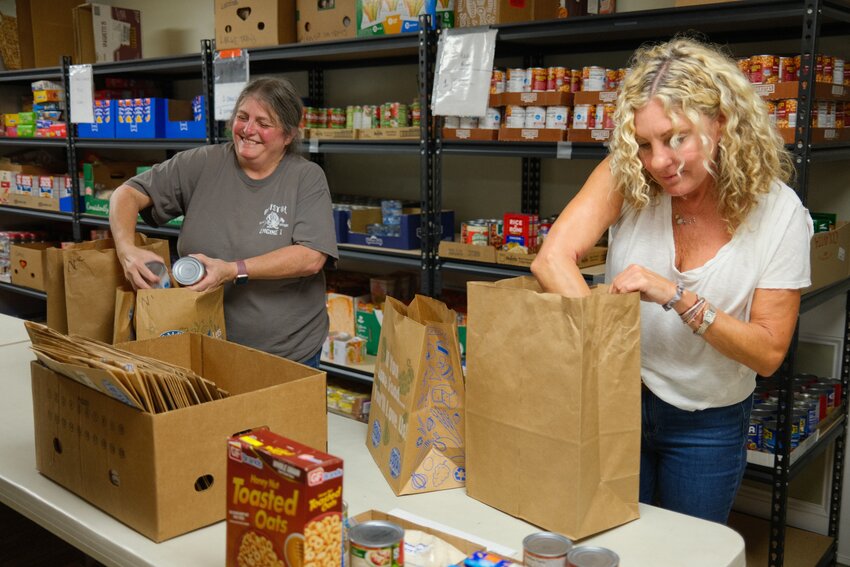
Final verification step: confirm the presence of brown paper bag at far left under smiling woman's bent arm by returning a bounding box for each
[45,234,170,343]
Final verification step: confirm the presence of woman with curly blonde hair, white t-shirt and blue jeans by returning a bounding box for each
[532,38,812,522]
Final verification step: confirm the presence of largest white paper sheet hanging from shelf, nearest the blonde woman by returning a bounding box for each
[431,27,496,116]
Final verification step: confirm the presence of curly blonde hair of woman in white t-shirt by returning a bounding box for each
[610,37,794,233]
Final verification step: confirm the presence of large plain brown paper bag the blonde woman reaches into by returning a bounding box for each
[466,276,640,539]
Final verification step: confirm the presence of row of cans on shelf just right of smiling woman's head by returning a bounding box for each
[301,100,422,130]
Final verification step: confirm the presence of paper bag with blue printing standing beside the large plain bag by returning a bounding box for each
[366,295,466,495]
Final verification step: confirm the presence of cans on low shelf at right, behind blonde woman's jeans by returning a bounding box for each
[747,374,842,453]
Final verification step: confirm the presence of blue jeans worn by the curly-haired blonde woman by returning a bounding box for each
[640,388,753,524]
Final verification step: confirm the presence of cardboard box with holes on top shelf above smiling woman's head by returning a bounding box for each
[215,0,295,49]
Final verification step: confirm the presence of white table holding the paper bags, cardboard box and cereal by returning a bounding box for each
[0,317,745,567]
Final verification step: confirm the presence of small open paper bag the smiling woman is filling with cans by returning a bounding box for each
[135,287,227,341]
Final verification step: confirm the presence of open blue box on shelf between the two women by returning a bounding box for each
[348,208,455,250]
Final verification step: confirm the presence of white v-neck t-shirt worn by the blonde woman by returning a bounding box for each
[605,181,813,410]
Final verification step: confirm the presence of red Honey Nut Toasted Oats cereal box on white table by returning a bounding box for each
[227,428,342,567]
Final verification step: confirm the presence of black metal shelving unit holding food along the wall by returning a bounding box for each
[0,6,850,566]
